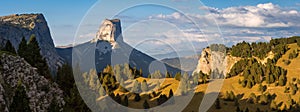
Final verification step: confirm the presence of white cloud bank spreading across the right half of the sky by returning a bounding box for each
[148,3,300,46]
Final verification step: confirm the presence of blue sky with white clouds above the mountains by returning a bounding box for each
[0,0,300,57]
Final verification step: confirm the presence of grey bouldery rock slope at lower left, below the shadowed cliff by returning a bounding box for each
[0,54,65,112]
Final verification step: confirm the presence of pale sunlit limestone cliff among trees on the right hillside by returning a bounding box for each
[194,48,240,76]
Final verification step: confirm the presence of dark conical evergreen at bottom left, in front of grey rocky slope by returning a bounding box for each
[9,81,31,112]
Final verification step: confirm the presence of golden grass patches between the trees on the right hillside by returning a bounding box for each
[109,44,300,112]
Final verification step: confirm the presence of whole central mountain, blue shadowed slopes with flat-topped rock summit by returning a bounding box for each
[69,19,180,76]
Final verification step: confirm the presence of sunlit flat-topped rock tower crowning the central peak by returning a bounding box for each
[94,19,123,47]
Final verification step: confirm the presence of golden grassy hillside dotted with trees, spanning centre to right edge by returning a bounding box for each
[79,37,300,112]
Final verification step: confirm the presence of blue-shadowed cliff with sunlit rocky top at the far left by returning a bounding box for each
[0,14,63,72]
